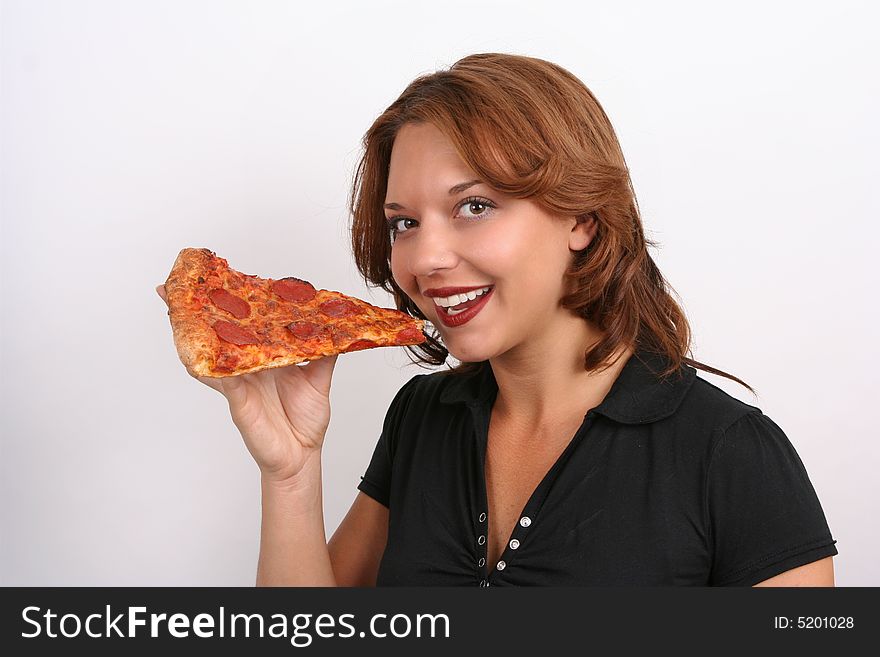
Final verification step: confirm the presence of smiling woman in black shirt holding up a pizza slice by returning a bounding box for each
[156,53,837,586]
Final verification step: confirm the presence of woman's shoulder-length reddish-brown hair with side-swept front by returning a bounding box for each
[349,53,755,394]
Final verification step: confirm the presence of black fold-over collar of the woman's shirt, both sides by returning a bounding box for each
[440,349,696,424]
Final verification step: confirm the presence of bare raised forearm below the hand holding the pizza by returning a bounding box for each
[257,452,336,586]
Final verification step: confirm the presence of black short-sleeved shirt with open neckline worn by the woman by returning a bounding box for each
[358,351,837,586]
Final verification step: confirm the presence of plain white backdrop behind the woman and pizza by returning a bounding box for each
[0,0,880,586]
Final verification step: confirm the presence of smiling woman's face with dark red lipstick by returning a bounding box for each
[385,124,592,361]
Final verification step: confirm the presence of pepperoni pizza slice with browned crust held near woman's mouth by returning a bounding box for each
[165,249,426,377]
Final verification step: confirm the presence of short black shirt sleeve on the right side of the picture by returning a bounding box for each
[706,410,837,586]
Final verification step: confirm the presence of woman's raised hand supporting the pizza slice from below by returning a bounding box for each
[156,285,337,482]
